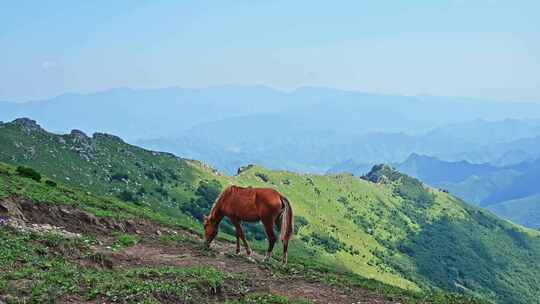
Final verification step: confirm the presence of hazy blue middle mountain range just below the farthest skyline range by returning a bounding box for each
[140,114,540,173]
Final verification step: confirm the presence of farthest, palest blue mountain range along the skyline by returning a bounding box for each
[0,85,540,141]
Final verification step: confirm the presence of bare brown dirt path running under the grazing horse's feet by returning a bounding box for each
[97,231,393,304]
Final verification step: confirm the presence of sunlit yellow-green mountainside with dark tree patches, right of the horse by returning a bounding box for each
[230,167,540,303]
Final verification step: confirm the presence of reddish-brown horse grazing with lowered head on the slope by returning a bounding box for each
[204,186,294,263]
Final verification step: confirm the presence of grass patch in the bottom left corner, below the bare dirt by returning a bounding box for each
[0,227,272,303]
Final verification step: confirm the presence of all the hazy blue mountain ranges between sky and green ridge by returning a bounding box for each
[0,86,540,227]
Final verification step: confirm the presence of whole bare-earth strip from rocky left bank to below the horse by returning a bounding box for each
[0,197,398,304]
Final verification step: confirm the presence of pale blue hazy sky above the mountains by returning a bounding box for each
[0,0,540,102]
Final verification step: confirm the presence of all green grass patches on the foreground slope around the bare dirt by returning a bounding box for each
[0,163,483,304]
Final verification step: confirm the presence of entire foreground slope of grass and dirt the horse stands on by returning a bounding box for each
[0,163,485,304]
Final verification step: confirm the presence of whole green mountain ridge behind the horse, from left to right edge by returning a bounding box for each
[0,120,540,303]
